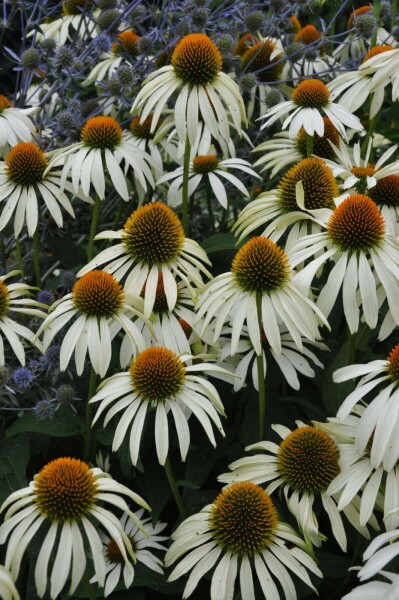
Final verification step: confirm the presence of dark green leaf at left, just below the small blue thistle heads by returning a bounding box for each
[6,407,85,438]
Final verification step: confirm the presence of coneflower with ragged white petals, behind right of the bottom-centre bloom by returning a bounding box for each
[218,424,367,552]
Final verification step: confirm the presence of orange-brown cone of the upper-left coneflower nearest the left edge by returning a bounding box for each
[6,142,48,185]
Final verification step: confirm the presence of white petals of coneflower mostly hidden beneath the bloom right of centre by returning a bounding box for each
[219,324,328,391]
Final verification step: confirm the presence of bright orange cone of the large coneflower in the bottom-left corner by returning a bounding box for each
[33,458,98,522]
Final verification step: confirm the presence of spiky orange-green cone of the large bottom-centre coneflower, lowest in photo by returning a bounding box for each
[209,481,278,556]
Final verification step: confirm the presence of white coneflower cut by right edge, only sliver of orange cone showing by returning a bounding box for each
[333,344,399,471]
